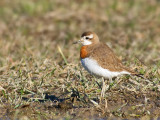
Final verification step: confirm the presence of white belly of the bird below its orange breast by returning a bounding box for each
[81,58,130,79]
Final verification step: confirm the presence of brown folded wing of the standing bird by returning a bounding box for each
[90,43,133,73]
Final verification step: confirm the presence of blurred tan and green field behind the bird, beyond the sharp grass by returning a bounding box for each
[0,0,160,66]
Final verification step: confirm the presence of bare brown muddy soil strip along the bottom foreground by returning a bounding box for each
[0,89,160,119]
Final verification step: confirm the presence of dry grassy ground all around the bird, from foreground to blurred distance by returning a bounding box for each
[0,0,160,119]
